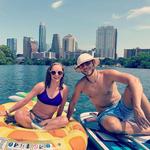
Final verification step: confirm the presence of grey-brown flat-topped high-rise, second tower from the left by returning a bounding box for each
[23,37,32,58]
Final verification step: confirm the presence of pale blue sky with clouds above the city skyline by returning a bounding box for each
[0,0,150,56]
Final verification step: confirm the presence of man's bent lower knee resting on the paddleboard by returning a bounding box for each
[101,117,122,133]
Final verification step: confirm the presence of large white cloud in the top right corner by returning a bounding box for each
[127,6,150,19]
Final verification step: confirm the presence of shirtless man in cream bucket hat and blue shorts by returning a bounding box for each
[67,53,150,134]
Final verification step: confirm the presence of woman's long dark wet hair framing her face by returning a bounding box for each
[45,62,64,90]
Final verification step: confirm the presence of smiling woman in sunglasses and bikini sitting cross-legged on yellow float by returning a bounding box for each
[0,63,68,130]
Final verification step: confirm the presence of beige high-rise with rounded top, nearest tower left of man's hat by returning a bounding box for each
[62,34,77,58]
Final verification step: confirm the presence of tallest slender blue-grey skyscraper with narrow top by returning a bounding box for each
[39,23,46,52]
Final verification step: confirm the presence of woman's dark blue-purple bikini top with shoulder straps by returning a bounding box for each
[37,89,62,106]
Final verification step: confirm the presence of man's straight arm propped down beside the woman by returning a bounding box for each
[67,83,82,120]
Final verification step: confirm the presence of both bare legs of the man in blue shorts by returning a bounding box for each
[100,87,150,134]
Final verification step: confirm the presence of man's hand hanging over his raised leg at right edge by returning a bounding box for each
[134,108,150,129]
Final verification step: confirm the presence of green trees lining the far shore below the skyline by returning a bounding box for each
[0,45,150,69]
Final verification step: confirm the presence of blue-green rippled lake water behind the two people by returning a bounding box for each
[0,65,150,149]
